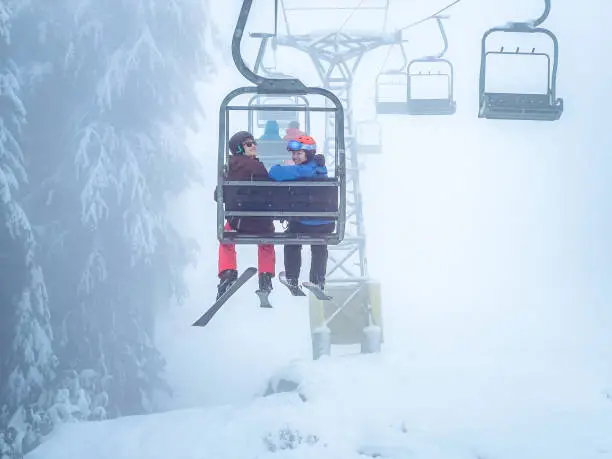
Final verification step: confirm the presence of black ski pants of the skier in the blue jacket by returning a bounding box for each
[285,221,335,285]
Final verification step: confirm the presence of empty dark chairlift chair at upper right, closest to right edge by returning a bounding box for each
[478,0,563,121]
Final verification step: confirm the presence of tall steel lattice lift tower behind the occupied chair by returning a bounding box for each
[275,0,402,358]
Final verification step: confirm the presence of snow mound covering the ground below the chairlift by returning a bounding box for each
[27,353,612,459]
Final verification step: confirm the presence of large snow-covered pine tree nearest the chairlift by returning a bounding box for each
[11,0,216,419]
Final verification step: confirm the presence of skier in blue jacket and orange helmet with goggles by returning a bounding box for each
[268,135,335,295]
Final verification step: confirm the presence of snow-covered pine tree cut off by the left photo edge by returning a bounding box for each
[0,2,56,459]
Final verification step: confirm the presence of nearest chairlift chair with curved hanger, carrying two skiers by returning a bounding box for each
[215,0,346,245]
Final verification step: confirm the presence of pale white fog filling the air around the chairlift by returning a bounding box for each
[157,0,612,407]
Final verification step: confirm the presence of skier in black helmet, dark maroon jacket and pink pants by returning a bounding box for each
[215,131,276,299]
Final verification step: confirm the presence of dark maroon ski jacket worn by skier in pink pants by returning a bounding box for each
[215,155,274,233]
